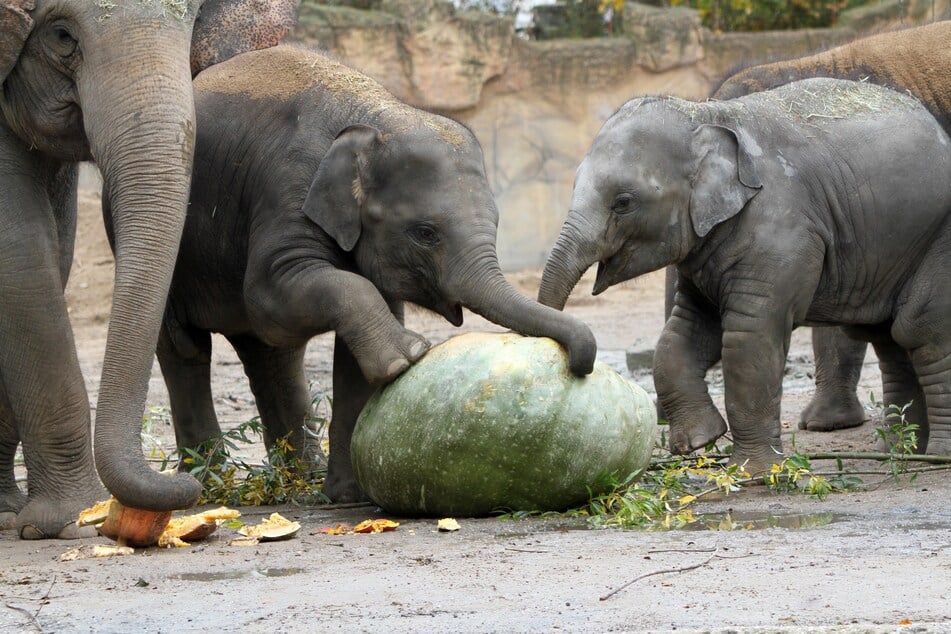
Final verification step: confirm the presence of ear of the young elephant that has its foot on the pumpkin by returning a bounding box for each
[303,125,382,251]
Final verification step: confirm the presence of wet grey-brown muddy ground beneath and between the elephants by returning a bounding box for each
[0,185,951,632]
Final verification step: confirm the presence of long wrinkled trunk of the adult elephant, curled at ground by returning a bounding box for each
[78,22,201,511]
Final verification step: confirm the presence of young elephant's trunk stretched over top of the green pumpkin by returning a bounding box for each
[458,238,597,376]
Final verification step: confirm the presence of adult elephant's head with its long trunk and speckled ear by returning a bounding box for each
[0,0,298,510]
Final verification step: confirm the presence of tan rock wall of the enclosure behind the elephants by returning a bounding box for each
[289,0,951,271]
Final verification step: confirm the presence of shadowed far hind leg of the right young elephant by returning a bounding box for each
[873,337,928,453]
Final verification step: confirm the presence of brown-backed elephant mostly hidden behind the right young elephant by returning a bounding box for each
[666,21,951,431]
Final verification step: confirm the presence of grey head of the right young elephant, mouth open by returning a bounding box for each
[538,98,761,309]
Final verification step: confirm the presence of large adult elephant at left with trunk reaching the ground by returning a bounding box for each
[0,0,297,538]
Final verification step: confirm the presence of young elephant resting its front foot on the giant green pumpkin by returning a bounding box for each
[106,46,596,501]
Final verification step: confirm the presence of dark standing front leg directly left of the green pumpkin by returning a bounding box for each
[324,337,373,502]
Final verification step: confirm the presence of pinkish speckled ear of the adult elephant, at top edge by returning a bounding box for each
[191,0,300,77]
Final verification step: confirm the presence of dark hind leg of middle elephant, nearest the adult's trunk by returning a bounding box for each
[156,319,221,464]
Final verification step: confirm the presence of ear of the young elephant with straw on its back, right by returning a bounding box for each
[690,125,763,238]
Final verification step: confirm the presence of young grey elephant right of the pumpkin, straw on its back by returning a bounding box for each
[539,79,951,472]
